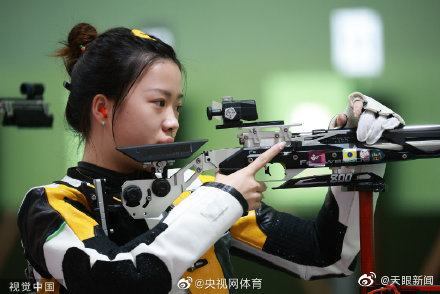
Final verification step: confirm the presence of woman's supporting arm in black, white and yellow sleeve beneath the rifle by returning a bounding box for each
[231,172,385,280]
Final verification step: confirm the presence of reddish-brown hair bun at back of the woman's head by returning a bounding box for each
[55,23,98,74]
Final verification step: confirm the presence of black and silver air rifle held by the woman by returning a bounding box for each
[94,97,440,228]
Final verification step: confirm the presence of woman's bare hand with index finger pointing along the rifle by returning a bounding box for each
[215,142,286,210]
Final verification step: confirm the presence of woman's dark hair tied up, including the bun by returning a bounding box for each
[55,23,183,141]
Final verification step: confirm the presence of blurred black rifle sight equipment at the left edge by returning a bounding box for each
[0,83,53,128]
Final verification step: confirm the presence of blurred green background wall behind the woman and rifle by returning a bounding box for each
[0,0,440,293]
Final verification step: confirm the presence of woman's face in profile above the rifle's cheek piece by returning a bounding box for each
[114,59,183,147]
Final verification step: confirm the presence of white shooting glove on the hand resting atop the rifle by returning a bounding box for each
[329,92,405,144]
